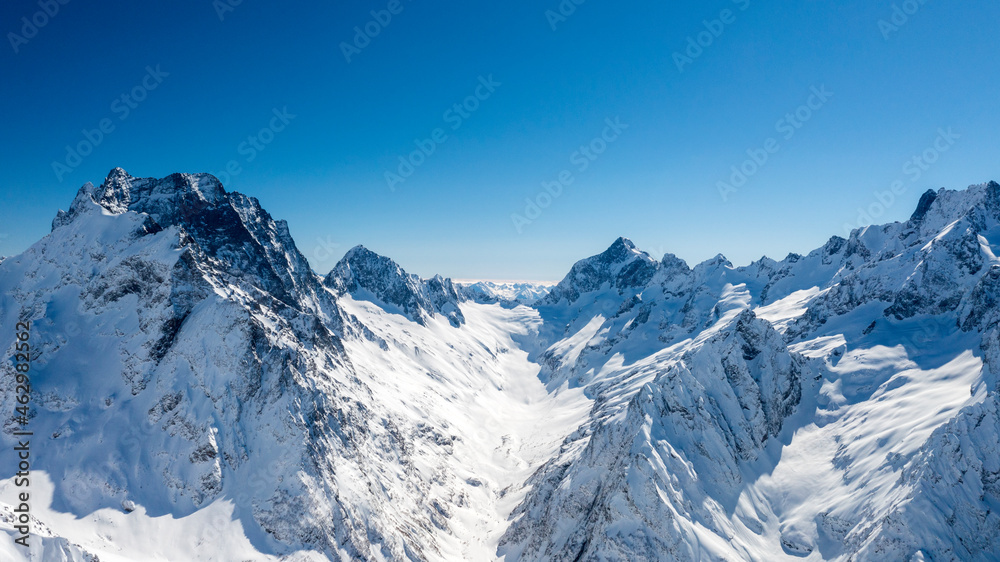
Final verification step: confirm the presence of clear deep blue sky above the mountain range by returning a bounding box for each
[0,0,1000,280]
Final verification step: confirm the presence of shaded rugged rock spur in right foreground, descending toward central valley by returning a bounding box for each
[501,311,803,561]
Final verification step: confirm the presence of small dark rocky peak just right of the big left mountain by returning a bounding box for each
[324,246,465,327]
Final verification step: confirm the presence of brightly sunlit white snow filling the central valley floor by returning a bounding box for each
[340,296,600,560]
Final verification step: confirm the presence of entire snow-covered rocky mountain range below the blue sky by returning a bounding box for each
[0,169,1000,561]
